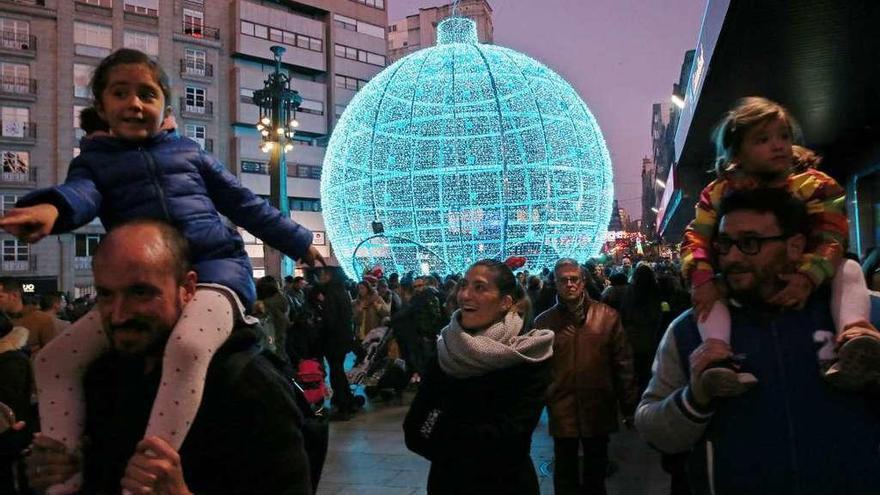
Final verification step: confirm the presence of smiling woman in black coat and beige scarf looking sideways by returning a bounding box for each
[403,260,553,494]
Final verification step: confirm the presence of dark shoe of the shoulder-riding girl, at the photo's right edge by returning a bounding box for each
[825,335,880,391]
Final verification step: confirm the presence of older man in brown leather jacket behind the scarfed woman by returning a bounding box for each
[535,258,639,495]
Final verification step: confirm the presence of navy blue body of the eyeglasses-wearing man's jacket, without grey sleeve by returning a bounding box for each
[670,291,880,495]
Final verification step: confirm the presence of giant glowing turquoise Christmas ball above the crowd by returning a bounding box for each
[321,17,613,277]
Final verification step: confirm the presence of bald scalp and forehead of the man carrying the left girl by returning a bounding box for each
[92,219,191,281]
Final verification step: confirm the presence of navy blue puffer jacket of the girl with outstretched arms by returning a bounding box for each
[17,131,312,308]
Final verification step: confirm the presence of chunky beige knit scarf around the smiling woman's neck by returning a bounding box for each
[437,311,553,378]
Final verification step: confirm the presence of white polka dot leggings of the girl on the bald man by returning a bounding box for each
[34,286,237,495]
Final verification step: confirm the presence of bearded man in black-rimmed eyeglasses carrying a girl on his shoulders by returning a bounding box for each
[636,189,880,495]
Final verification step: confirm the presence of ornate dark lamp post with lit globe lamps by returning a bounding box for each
[253,45,302,280]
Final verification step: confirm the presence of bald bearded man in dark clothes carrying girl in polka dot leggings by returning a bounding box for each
[28,220,312,495]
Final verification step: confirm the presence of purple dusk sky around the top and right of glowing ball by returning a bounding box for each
[386,0,709,218]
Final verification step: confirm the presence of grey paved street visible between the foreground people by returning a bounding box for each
[318,393,669,495]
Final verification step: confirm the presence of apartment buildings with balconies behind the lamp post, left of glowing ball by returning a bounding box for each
[0,0,387,295]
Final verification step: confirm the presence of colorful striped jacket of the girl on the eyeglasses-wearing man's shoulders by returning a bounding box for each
[681,168,849,287]
